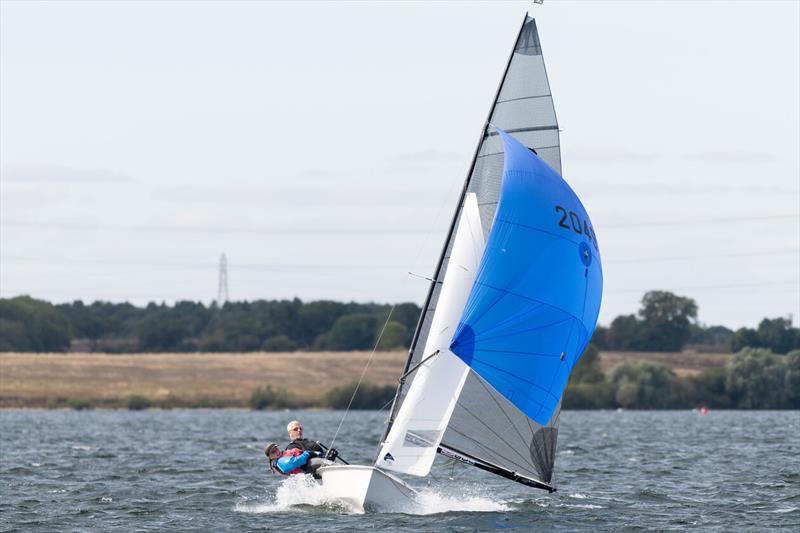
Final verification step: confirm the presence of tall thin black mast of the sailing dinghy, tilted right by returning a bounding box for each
[381,13,528,442]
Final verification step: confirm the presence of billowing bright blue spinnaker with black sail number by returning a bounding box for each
[450,129,603,425]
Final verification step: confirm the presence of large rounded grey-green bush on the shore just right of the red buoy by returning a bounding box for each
[725,348,786,409]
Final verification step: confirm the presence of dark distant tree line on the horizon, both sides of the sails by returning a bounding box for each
[0,291,800,354]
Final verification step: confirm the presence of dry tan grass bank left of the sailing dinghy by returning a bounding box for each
[0,352,406,407]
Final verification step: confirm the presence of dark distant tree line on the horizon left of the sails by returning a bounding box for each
[0,296,420,353]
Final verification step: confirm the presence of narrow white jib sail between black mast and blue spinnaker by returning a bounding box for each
[375,193,484,476]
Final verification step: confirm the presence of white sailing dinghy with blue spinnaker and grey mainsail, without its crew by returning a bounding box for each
[318,15,603,511]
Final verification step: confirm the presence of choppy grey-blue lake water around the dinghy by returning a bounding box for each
[0,410,800,533]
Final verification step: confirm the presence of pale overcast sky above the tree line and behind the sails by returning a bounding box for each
[0,0,800,329]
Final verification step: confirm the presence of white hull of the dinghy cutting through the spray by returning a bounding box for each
[317,465,417,512]
